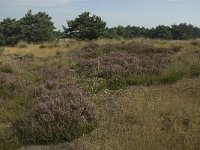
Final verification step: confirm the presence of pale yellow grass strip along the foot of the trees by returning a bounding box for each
[4,38,200,58]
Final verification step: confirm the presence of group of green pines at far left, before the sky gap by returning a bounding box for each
[0,10,55,46]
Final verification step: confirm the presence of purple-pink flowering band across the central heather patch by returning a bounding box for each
[77,52,169,78]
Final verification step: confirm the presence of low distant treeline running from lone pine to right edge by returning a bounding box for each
[105,23,200,40]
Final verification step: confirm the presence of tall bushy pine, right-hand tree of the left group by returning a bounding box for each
[20,10,55,42]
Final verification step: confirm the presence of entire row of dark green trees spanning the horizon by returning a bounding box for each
[0,10,200,46]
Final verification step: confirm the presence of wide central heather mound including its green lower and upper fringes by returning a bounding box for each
[73,42,171,89]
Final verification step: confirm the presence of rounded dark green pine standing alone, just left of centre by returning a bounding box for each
[63,12,106,40]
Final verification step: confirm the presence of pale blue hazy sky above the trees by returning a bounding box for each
[0,0,200,30]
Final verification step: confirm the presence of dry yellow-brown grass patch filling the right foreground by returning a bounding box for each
[19,78,200,150]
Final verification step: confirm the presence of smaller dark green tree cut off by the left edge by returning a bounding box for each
[0,18,21,46]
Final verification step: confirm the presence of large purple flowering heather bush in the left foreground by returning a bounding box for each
[13,83,97,144]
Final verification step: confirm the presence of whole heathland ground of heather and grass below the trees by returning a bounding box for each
[0,38,200,149]
